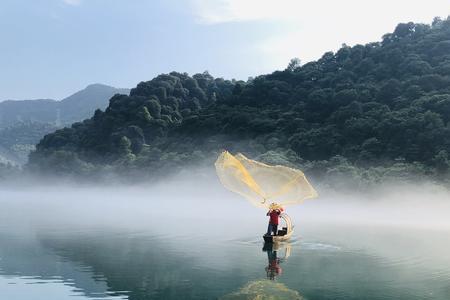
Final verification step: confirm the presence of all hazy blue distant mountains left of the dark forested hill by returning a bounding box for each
[0,84,129,164]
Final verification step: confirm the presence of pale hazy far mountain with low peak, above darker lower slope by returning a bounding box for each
[0,84,129,129]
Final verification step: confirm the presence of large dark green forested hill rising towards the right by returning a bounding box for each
[29,18,450,183]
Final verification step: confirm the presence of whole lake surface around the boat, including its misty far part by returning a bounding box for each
[0,183,450,300]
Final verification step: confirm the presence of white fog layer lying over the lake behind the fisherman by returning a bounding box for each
[0,174,450,234]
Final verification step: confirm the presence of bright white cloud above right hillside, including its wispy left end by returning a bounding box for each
[189,0,450,71]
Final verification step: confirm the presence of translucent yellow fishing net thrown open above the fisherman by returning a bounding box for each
[215,151,317,208]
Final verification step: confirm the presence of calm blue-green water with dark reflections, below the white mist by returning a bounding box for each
[0,219,450,300]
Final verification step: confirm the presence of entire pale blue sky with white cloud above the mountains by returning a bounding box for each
[0,0,450,101]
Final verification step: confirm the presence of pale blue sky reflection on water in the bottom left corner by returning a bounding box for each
[0,232,127,300]
